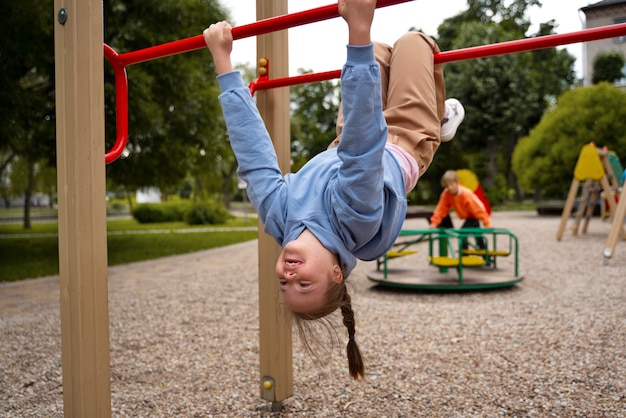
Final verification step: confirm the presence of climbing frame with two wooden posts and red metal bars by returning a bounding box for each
[54,0,626,417]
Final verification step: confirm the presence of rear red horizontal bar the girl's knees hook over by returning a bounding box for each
[250,23,626,94]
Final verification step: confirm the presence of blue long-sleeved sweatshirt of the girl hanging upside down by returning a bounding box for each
[218,44,406,277]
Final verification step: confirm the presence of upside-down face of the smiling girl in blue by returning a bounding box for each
[276,229,343,314]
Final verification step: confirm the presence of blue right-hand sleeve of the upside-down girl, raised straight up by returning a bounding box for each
[333,44,387,247]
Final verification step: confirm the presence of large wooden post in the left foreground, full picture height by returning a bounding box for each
[54,0,111,417]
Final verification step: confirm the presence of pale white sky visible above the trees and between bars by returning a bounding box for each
[221,0,598,77]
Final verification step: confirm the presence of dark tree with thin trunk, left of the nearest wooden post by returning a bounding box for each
[0,0,56,228]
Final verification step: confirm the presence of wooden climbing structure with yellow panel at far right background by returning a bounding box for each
[556,142,626,264]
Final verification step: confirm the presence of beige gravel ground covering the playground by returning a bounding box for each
[0,212,626,417]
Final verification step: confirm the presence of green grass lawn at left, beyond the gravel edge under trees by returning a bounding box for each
[0,219,258,282]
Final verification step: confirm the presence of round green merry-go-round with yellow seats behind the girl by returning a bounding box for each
[367,228,524,290]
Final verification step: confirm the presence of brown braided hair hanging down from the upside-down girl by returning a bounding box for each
[293,279,365,380]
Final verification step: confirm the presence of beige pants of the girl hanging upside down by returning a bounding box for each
[329,32,446,177]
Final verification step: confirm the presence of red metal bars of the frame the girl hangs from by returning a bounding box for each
[104,0,626,164]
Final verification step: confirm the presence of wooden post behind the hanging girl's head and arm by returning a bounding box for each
[256,0,293,410]
